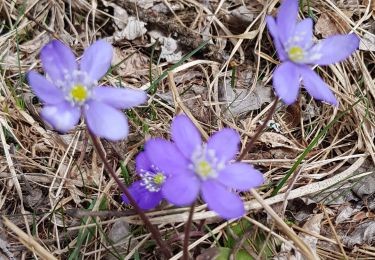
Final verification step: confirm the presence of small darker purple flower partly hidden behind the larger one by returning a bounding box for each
[122,152,167,210]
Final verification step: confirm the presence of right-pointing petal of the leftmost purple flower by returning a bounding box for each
[94,87,147,109]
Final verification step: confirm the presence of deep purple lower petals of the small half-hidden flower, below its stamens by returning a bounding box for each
[121,181,163,210]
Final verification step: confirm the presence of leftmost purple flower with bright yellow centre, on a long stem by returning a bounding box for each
[27,40,147,141]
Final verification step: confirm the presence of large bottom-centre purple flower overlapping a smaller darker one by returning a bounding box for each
[145,115,264,219]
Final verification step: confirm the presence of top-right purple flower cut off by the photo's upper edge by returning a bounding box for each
[267,0,359,105]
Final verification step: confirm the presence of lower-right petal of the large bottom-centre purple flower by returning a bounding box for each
[202,180,245,219]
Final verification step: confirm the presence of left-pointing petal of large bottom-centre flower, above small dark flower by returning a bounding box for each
[145,138,189,175]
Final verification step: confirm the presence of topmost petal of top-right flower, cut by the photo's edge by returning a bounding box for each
[276,0,298,43]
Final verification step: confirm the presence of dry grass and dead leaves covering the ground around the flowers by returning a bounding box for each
[0,0,375,259]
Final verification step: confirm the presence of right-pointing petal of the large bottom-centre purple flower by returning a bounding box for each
[218,163,264,191]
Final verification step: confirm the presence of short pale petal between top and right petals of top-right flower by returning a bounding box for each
[288,18,313,50]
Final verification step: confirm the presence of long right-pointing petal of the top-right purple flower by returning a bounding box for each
[308,33,359,65]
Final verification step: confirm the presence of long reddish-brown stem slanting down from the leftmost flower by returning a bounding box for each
[89,131,172,259]
